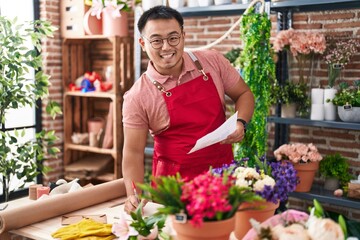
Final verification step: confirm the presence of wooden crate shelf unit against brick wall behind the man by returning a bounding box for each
[62,36,134,180]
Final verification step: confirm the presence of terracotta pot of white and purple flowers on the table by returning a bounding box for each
[213,157,297,239]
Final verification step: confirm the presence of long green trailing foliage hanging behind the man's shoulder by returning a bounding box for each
[234,8,276,165]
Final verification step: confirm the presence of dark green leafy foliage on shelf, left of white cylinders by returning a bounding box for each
[270,81,310,116]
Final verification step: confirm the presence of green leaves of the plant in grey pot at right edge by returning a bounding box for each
[332,80,360,107]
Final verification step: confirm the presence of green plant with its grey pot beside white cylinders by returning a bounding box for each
[327,80,360,122]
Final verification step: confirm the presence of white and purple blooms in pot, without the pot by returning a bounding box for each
[213,157,298,204]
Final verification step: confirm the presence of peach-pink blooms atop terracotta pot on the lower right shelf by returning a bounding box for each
[274,143,322,163]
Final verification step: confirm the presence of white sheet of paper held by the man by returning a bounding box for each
[188,112,237,154]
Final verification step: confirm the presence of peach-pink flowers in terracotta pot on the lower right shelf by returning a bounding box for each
[274,143,322,192]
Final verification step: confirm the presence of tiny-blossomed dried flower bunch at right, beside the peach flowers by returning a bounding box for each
[324,37,360,88]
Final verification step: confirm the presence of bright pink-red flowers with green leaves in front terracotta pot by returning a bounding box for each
[139,171,261,240]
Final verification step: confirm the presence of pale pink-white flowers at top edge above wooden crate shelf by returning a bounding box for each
[85,0,141,19]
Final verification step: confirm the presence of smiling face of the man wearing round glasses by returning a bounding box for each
[139,19,184,75]
